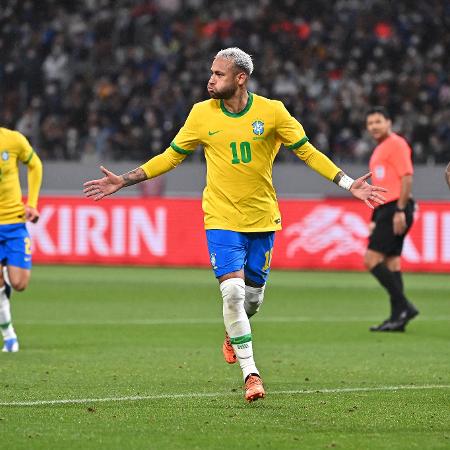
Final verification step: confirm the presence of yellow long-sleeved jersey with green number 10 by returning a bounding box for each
[141,92,340,232]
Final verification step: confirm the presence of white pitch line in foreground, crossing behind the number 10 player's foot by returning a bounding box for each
[0,384,450,407]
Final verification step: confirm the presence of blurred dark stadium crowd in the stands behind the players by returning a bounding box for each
[0,0,450,164]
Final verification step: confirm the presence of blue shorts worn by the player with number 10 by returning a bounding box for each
[206,230,275,285]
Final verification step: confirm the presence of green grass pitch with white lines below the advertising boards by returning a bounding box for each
[0,266,450,450]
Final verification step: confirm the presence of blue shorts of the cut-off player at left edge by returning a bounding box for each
[0,223,31,269]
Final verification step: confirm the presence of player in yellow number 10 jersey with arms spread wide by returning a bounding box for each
[84,48,384,402]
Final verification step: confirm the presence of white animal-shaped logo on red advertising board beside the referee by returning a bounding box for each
[284,206,368,263]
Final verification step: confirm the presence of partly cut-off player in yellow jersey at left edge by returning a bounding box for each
[0,128,42,352]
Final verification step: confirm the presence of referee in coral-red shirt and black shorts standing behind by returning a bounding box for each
[364,107,419,331]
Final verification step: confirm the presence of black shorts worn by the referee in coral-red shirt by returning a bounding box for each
[368,199,415,256]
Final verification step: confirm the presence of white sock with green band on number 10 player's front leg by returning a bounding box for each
[220,278,259,380]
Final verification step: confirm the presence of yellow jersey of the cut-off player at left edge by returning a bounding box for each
[0,128,42,224]
